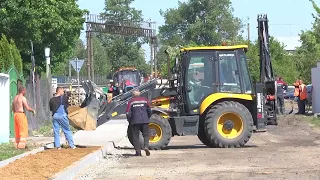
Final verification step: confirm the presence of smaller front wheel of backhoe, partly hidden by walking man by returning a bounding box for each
[127,114,172,150]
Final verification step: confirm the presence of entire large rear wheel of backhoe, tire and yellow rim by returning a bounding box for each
[204,101,253,148]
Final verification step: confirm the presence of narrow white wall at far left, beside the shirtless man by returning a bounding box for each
[0,73,10,144]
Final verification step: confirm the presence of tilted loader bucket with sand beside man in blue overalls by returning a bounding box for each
[68,81,100,131]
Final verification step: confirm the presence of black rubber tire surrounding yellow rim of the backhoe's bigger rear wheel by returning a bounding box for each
[204,101,253,148]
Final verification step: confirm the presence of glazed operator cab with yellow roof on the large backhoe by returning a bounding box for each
[178,45,253,115]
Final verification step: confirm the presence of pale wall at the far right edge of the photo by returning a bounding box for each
[311,62,320,114]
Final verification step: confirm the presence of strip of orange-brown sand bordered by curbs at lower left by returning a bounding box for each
[0,147,100,180]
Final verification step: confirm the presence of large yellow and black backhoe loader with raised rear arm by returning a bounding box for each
[70,15,276,149]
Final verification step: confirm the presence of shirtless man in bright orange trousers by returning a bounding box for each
[12,87,36,149]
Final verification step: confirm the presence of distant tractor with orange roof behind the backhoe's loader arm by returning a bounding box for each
[112,67,141,93]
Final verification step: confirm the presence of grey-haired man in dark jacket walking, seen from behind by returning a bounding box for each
[126,90,151,156]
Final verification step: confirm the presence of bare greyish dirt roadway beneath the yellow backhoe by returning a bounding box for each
[97,115,320,180]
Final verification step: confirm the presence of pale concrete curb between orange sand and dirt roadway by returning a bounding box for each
[50,141,116,180]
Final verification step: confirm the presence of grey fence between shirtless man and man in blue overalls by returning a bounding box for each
[26,76,51,131]
